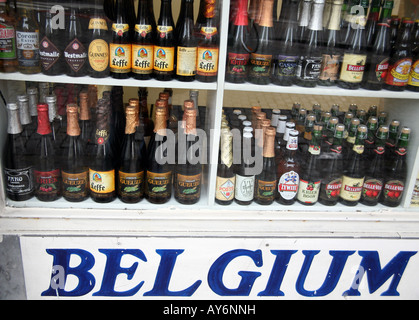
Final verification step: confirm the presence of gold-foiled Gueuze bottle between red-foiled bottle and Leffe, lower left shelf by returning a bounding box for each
[61,104,89,202]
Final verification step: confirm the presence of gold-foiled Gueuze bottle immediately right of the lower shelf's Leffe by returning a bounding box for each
[117,100,146,203]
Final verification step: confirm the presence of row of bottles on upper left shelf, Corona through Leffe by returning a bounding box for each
[0,0,219,82]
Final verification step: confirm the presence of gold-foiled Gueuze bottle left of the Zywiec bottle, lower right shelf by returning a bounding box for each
[255,127,277,205]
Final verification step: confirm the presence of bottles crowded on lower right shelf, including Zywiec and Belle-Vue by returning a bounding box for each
[215,103,411,207]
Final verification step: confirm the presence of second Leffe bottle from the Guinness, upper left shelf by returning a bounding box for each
[132,0,156,80]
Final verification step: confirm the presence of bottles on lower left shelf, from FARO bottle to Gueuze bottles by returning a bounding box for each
[3,83,206,204]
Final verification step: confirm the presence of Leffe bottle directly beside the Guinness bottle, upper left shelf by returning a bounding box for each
[109,0,132,79]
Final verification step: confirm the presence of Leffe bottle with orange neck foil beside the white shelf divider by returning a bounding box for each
[196,0,220,82]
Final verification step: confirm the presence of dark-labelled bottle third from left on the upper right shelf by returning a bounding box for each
[272,0,299,86]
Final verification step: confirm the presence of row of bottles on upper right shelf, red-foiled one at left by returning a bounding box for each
[226,0,419,91]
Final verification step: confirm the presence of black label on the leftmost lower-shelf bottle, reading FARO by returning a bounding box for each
[4,167,34,196]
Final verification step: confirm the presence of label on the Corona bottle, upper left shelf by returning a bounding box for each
[16,31,39,67]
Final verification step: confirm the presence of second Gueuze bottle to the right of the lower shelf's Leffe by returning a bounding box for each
[145,100,172,204]
